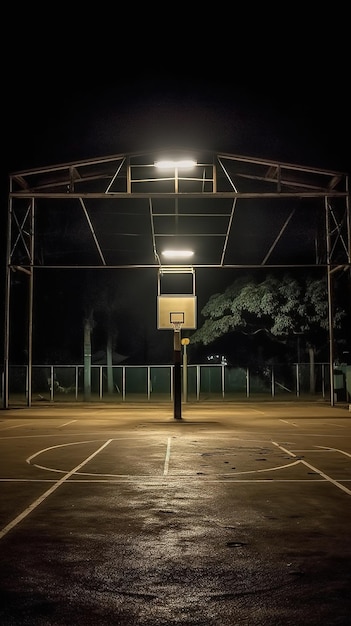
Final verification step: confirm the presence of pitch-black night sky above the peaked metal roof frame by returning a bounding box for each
[1,3,351,176]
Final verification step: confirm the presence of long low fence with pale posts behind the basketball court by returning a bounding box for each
[1,363,351,405]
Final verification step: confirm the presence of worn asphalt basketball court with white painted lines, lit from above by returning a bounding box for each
[0,402,351,626]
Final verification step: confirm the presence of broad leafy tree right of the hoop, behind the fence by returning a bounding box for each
[190,274,343,391]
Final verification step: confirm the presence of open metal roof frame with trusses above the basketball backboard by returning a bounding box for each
[9,153,350,269]
